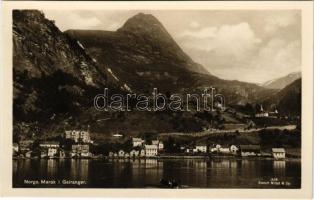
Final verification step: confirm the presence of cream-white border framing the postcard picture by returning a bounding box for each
[0,1,313,199]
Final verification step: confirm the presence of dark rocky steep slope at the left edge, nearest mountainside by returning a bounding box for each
[13,10,123,121]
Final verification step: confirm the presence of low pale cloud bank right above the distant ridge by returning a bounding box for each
[210,38,301,83]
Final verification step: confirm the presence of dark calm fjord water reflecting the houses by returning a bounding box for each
[13,158,301,188]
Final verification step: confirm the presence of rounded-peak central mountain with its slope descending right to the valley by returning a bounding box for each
[66,13,274,103]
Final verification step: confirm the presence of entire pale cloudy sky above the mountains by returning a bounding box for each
[44,10,301,83]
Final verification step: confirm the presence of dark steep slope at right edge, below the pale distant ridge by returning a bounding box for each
[265,78,302,116]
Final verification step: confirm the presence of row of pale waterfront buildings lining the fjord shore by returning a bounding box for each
[13,130,286,159]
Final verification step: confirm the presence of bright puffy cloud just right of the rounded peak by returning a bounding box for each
[180,22,261,59]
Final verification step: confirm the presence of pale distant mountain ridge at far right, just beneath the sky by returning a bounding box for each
[262,72,301,89]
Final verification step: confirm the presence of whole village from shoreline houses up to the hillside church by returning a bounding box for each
[13,105,300,159]
